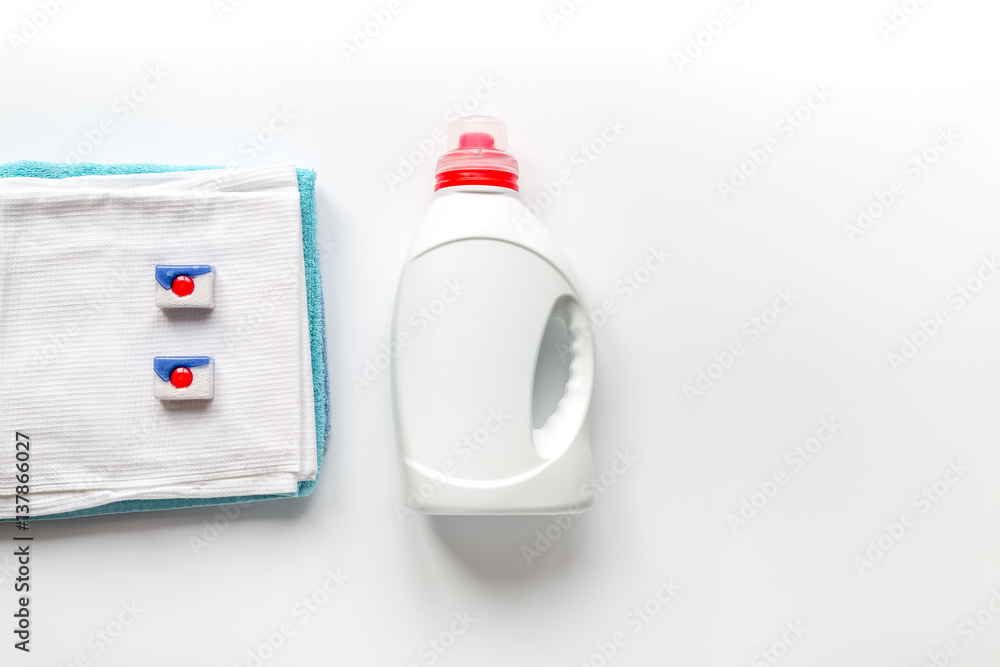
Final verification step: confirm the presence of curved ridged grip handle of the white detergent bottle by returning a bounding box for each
[532,295,596,459]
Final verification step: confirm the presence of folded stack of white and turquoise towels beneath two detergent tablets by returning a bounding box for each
[0,163,329,519]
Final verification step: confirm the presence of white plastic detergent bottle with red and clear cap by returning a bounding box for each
[392,116,594,514]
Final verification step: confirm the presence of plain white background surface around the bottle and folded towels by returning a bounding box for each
[0,0,1000,667]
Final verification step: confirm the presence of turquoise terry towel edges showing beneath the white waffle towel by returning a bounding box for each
[0,162,330,521]
